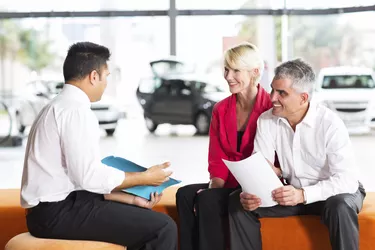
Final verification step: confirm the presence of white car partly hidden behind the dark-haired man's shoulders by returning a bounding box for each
[16,81,122,136]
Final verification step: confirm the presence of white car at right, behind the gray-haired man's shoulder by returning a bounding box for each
[314,67,375,134]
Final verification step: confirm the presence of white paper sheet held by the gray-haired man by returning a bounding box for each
[223,152,283,207]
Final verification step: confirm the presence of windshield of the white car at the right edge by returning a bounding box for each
[322,75,375,89]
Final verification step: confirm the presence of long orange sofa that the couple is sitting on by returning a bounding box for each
[0,187,375,250]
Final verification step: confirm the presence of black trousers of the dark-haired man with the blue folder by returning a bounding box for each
[26,191,177,250]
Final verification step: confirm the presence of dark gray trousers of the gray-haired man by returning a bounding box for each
[229,184,366,250]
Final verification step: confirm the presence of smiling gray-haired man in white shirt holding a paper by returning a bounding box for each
[229,59,366,250]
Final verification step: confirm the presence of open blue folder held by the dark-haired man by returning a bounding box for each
[102,156,181,200]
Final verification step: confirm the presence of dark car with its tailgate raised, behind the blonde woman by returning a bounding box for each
[137,60,228,134]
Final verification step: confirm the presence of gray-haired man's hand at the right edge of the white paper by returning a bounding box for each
[272,185,304,206]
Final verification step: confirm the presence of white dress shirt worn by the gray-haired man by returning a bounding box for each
[254,102,358,203]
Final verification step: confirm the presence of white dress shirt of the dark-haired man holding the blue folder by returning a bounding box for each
[21,84,125,208]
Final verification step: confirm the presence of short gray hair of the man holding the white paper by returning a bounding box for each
[274,58,315,101]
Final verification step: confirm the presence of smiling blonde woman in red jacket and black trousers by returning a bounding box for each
[176,43,280,250]
